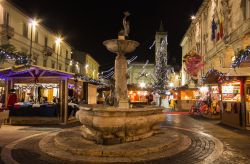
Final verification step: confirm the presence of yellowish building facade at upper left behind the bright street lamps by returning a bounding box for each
[0,0,72,72]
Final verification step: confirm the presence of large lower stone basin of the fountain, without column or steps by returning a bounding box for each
[76,107,165,145]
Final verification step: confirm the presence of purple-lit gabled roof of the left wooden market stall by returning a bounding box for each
[0,65,74,79]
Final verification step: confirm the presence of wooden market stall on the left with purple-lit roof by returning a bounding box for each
[0,65,73,124]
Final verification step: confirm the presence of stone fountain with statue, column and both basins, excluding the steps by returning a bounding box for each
[77,12,164,144]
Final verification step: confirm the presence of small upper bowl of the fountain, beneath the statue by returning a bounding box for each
[103,39,139,55]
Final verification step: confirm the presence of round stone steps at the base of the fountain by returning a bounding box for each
[39,129,191,163]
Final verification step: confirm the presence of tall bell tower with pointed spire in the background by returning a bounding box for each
[155,21,168,65]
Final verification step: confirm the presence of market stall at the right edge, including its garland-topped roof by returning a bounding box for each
[225,46,250,130]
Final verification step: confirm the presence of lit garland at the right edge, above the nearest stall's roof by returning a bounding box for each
[232,46,250,68]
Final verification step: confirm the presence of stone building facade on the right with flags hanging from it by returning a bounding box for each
[181,0,250,85]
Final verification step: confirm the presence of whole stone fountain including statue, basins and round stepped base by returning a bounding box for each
[39,12,191,163]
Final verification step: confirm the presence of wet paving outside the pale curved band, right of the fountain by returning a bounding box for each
[163,115,250,164]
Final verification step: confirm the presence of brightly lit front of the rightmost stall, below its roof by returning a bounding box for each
[222,77,250,129]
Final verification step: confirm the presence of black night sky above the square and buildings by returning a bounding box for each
[12,0,202,70]
